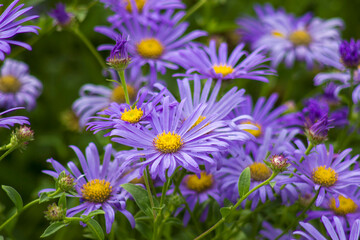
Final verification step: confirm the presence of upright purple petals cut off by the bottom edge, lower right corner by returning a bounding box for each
[293,216,360,240]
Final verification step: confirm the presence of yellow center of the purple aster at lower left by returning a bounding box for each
[81,179,112,203]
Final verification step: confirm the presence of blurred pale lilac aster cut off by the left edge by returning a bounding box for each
[0,59,42,110]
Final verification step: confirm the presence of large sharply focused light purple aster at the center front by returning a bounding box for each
[111,97,233,181]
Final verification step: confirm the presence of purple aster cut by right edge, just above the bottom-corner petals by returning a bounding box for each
[307,188,360,230]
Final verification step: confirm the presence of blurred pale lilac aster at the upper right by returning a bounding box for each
[239,4,343,68]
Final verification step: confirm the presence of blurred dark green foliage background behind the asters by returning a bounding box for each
[0,0,360,240]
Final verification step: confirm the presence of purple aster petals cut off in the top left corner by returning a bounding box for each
[0,0,39,60]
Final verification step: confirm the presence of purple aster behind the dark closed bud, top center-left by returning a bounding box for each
[95,12,206,84]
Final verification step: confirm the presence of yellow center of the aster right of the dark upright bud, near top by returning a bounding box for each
[136,38,164,58]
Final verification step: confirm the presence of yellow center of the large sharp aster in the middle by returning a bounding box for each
[154,131,183,153]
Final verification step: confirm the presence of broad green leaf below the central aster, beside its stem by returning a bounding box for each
[121,183,152,216]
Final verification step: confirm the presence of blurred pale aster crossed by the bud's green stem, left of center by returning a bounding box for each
[72,69,146,127]
